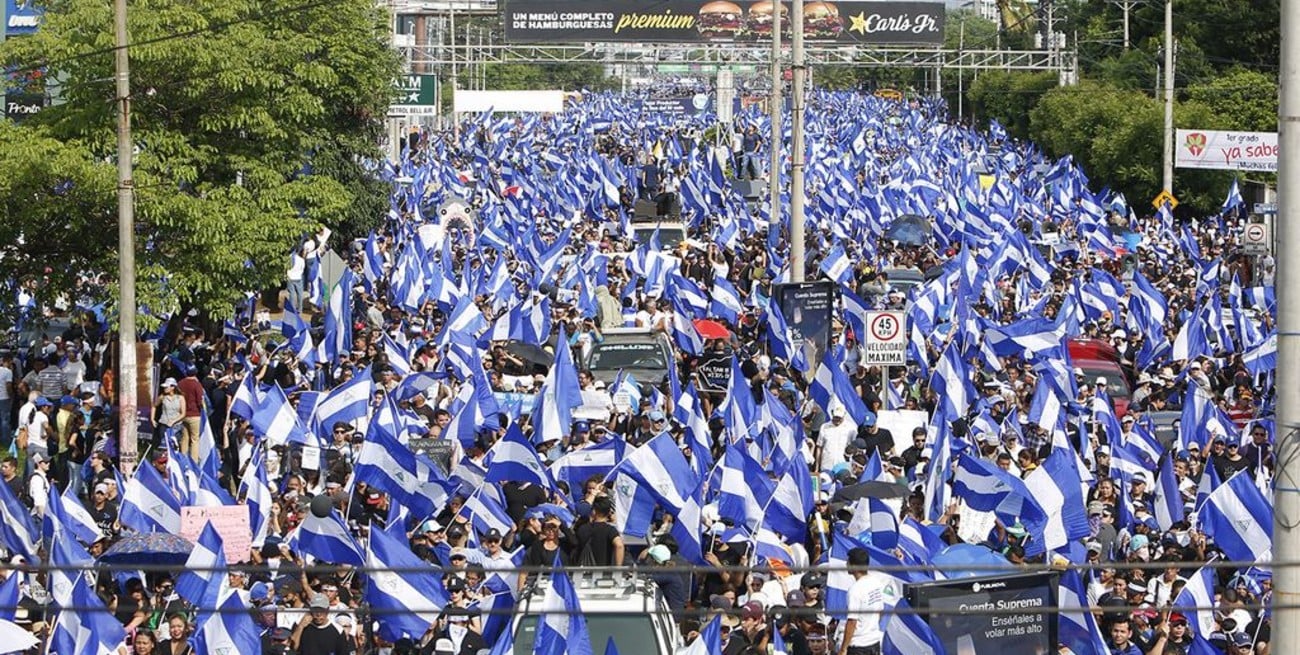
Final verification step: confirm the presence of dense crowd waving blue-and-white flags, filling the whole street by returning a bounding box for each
[0,88,1275,655]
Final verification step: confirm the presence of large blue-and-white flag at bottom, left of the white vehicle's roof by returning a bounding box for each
[361,526,447,642]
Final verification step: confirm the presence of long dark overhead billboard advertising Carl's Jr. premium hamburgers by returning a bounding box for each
[503,0,944,45]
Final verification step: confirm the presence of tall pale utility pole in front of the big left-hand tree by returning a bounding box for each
[113,0,139,477]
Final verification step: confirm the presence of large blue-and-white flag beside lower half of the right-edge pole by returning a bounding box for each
[1197,469,1273,561]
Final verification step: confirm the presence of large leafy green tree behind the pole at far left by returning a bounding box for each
[0,0,399,327]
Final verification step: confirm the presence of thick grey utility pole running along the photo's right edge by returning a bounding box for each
[1273,3,1300,636]
